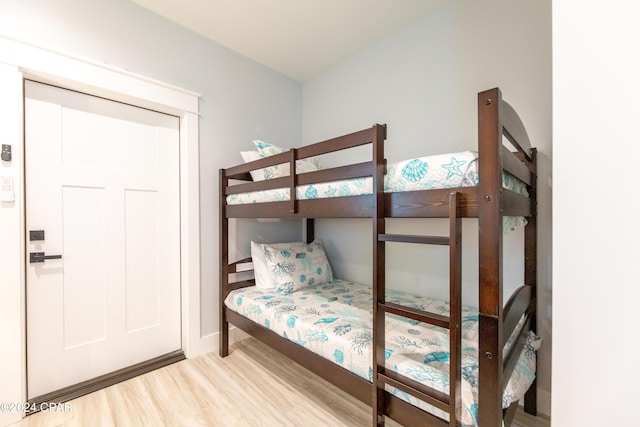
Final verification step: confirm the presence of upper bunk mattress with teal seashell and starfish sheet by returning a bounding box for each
[227,151,528,231]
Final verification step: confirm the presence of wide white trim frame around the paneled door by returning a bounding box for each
[0,37,200,425]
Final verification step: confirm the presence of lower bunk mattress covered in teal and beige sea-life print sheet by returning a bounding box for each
[225,280,540,426]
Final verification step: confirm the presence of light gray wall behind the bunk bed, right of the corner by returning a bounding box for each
[303,0,551,413]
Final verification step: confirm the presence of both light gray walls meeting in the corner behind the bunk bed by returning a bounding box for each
[0,0,551,416]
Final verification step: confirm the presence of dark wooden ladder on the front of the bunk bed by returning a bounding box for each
[373,192,462,426]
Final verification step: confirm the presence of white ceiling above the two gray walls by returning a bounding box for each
[132,0,446,81]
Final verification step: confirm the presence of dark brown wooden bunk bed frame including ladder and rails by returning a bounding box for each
[220,88,537,427]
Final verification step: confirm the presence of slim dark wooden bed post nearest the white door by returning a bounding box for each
[218,169,229,357]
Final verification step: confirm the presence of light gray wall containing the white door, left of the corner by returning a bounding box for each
[0,0,302,336]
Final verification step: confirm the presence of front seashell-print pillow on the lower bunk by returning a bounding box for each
[262,240,333,294]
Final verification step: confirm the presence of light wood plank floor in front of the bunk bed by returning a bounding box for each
[13,338,550,427]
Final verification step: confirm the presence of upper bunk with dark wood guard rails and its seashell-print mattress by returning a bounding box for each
[220,88,536,218]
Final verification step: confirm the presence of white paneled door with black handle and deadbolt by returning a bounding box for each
[25,81,181,399]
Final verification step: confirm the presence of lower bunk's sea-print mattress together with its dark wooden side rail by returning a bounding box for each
[224,280,540,426]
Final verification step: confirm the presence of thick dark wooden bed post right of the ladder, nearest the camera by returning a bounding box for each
[478,88,504,426]
